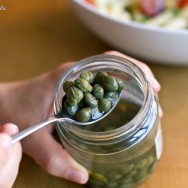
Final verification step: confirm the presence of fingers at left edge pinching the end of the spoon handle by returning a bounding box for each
[0,124,22,188]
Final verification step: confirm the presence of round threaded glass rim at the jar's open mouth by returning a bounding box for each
[54,55,150,141]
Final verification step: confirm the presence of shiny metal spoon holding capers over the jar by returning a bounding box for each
[12,94,121,144]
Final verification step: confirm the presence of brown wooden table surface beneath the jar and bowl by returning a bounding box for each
[0,0,188,188]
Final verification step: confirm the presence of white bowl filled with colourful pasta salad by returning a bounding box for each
[70,0,188,65]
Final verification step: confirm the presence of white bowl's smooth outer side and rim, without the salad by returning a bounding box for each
[70,0,188,65]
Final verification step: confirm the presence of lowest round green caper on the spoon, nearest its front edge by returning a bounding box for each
[76,107,91,122]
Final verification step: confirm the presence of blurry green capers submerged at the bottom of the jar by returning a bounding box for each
[87,154,157,188]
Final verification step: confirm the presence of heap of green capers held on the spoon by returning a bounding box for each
[63,71,124,122]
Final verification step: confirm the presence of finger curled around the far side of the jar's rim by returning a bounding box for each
[105,51,161,93]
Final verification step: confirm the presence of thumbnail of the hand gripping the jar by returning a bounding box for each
[67,169,87,184]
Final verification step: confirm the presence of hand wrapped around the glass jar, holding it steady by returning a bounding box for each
[0,51,160,184]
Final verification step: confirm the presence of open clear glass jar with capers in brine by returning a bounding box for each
[54,55,162,188]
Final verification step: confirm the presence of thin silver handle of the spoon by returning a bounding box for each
[12,116,58,144]
